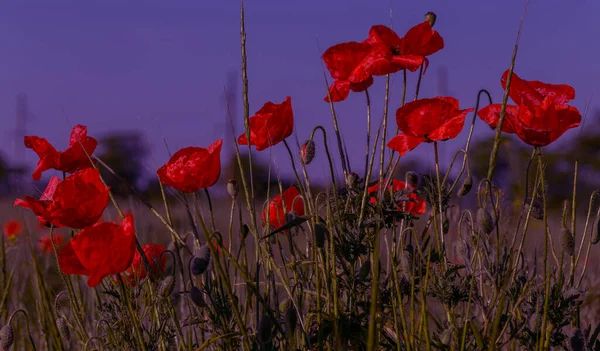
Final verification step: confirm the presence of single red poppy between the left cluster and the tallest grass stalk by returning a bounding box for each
[156,139,223,193]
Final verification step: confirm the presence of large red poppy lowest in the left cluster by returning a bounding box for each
[58,215,135,288]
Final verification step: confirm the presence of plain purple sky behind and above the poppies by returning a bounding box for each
[0,0,600,186]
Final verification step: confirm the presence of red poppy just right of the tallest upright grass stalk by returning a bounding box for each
[238,96,294,151]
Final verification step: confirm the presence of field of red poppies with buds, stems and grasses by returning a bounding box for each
[0,5,600,351]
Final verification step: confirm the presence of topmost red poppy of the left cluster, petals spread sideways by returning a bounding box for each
[25,124,98,180]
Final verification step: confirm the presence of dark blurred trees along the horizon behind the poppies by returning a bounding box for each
[0,110,600,209]
